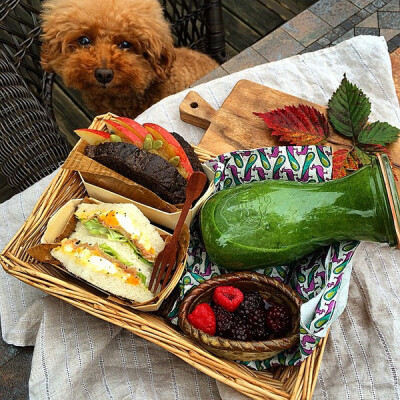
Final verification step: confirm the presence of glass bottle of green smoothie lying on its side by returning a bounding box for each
[200,155,400,270]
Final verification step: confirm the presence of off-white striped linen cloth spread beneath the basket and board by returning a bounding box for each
[0,36,400,400]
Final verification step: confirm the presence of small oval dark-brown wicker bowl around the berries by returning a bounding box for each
[178,271,302,361]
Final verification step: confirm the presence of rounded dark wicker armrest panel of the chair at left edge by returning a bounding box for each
[0,51,70,190]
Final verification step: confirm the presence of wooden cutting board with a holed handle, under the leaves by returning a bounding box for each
[179,80,400,180]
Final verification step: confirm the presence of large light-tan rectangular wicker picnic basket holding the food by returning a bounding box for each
[0,116,327,400]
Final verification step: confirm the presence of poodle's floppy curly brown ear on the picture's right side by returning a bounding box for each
[146,36,175,82]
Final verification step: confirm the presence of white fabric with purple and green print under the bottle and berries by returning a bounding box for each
[169,146,358,370]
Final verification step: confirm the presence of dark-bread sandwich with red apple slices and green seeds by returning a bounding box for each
[75,117,203,204]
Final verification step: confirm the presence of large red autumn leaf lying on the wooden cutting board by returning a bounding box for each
[254,104,329,145]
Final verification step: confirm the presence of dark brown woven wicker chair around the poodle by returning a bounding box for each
[0,0,225,191]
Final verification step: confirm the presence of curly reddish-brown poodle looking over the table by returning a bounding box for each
[42,0,217,118]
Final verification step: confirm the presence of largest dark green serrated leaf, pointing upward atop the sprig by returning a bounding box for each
[328,74,371,138]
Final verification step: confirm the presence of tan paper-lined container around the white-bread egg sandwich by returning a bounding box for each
[28,198,189,311]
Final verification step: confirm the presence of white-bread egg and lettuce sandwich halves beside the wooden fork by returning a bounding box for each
[51,202,164,303]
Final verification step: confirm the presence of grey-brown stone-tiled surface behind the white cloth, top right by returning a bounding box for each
[196,0,400,84]
